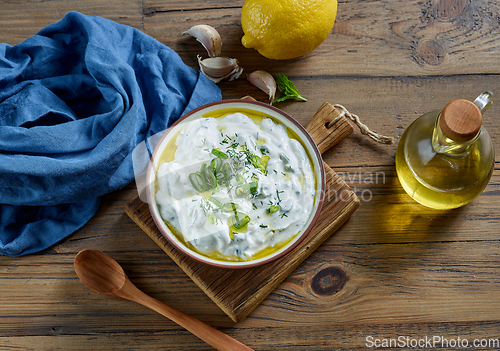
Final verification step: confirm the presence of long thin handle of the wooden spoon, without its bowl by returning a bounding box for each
[115,278,253,351]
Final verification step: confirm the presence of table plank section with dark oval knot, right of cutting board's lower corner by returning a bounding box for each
[260,241,500,325]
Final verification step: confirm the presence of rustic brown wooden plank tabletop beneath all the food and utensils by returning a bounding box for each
[0,0,500,351]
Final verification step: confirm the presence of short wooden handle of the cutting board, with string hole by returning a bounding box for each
[306,102,354,153]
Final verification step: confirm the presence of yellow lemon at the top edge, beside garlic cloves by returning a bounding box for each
[241,0,337,60]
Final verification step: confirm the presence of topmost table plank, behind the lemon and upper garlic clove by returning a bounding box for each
[144,0,500,77]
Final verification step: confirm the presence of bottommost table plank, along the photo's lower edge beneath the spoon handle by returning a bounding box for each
[0,323,498,351]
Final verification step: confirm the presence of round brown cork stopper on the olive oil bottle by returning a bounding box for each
[439,100,483,142]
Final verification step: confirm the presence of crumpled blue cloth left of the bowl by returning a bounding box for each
[0,12,221,256]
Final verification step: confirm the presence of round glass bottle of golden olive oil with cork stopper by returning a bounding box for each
[396,92,495,209]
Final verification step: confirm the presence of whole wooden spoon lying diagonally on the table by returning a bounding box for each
[75,249,253,351]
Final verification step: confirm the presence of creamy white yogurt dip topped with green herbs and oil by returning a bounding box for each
[156,112,316,261]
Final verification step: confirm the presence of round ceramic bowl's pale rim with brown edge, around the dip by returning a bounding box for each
[146,100,325,269]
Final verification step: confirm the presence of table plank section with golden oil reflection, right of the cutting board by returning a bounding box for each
[333,165,500,245]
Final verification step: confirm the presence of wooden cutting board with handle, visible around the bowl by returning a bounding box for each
[125,103,359,322]
